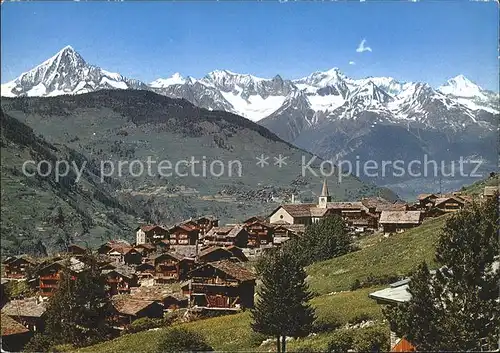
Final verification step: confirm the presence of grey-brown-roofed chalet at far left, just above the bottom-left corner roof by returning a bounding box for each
[2,298,47,332]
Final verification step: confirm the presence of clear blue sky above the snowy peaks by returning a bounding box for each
[1,0,498,90]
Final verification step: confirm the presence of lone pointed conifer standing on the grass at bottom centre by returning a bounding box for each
[252,249,315,353]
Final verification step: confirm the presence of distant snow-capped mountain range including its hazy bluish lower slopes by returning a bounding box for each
[1,47,500,198]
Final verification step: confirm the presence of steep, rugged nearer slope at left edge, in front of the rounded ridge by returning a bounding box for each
[0,110,139,255]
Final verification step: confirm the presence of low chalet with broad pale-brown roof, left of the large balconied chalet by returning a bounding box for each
[130,285,189,311]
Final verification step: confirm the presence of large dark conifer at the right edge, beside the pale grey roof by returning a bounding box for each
[386,195,500,351]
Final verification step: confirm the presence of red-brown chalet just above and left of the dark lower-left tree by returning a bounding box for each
[38,257,85,297]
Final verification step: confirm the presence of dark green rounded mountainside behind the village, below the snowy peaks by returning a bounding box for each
[0,89,397,253]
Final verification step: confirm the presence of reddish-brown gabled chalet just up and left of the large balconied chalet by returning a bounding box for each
[150,252,194,283]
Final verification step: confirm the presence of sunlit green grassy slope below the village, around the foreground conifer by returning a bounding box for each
[74,213,445,353]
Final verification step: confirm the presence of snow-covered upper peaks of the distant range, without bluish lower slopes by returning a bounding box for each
[1,45,499,124]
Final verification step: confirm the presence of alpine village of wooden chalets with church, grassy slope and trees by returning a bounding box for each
[1,173,499,352]
